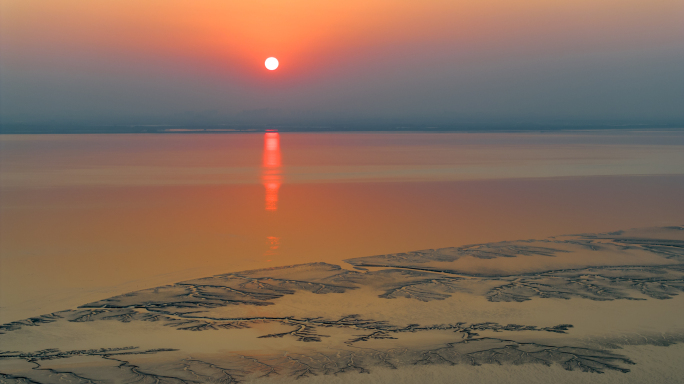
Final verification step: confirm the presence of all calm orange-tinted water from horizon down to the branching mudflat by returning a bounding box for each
[0,130,684,322]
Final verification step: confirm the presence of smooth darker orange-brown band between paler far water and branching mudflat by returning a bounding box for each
[0,175,684,323]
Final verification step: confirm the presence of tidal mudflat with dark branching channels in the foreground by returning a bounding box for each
[0,226,684,383]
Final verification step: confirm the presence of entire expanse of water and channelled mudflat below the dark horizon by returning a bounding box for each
[0,130,684,383]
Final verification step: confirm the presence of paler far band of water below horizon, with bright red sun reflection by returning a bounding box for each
[0,130,684,189]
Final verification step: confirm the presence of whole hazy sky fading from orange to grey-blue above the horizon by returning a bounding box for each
[0,0,684,124]
